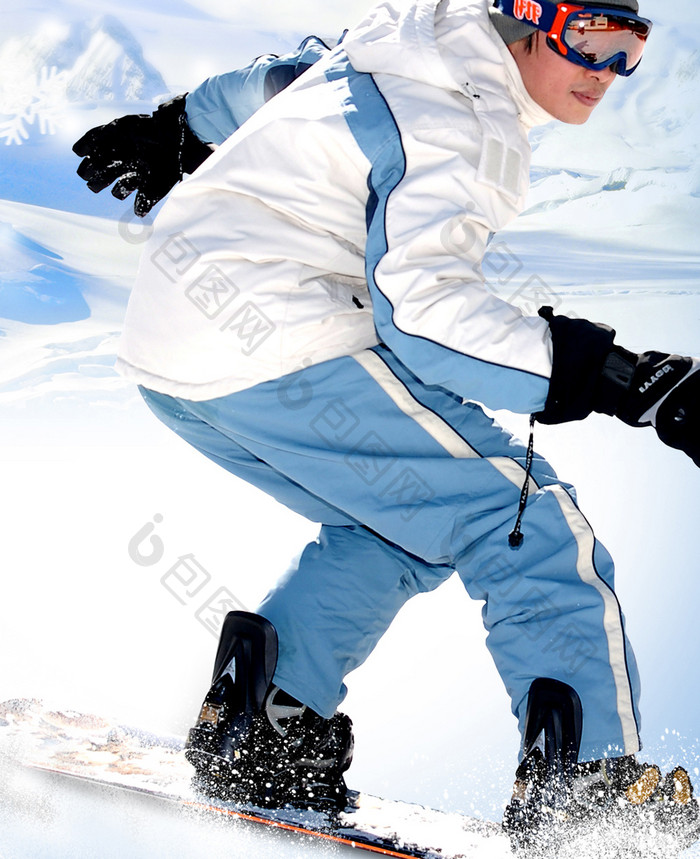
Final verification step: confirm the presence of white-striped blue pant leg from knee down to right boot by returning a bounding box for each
[457,485,640,760]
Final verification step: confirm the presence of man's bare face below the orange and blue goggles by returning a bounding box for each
[510,30,616,125]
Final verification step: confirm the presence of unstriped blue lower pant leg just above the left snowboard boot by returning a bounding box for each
[258,525,454,718]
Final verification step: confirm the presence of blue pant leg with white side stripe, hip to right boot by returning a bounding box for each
[139,348,639,757]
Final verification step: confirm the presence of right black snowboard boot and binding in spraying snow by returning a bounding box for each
[503,680,700,857]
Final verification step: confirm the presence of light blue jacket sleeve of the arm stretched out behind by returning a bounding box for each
[185,36,329,145]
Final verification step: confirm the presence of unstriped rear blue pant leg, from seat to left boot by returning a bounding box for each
[142,389,454,718]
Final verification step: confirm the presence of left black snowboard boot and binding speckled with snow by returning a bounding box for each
[185,612,353,811]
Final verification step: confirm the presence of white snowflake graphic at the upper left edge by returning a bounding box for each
[0,67,67,146]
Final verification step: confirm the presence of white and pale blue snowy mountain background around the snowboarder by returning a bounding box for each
[0,0,700,857]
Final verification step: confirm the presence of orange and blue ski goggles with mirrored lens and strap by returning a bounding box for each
[495,0,651,77]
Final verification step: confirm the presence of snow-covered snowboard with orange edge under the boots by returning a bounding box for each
[0,699,512,859]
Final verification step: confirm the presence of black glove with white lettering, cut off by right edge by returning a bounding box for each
[535,307,700,468]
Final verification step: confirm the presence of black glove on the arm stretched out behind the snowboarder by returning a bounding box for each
[73,95,212,217]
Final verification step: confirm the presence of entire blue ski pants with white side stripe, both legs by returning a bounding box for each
[142,346,640,760]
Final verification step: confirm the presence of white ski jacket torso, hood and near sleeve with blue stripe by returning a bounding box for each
[118,0,552,413]
